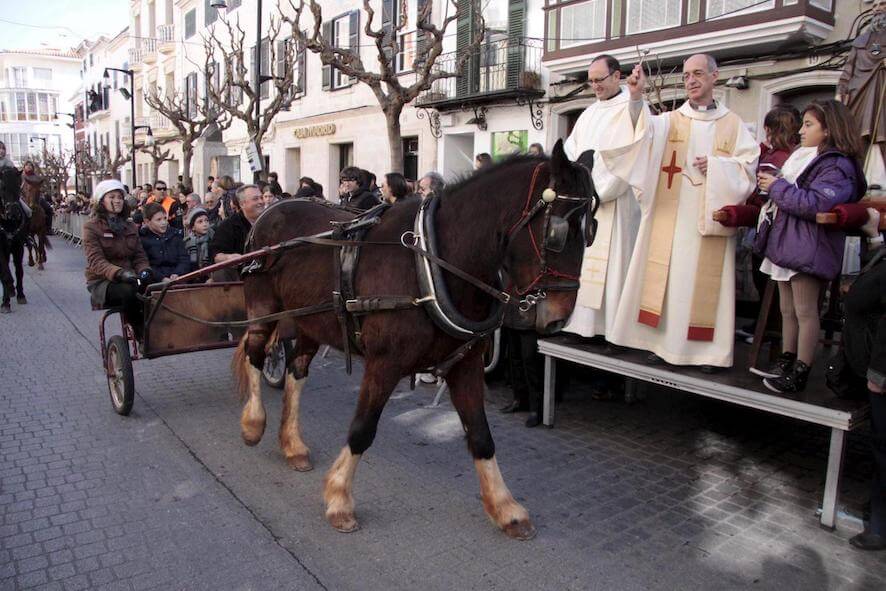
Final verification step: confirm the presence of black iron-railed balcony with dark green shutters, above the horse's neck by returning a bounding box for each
[416,37,544,110]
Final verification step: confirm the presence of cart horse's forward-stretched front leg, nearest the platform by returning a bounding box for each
[446,351,535,540]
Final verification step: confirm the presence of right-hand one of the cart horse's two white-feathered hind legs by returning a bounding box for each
[279,335,319,472]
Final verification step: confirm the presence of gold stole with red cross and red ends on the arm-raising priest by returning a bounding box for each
[637,111,741,341]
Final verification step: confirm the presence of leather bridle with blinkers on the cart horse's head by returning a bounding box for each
[506,162,600,312]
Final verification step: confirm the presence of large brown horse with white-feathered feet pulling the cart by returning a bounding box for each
[232,142,595,539]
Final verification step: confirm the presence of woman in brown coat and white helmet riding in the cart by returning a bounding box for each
[83,179,150,341]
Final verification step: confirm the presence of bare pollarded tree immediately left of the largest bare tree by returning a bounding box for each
[203,11,295,178]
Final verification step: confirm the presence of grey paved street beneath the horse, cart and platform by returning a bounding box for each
[0,242,886,591]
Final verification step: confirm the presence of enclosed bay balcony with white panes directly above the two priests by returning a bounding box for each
[544,0,836,74]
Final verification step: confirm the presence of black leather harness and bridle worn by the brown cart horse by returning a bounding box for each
[160,163,599,376]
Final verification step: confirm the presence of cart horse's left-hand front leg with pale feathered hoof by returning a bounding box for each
[323,359,400,532]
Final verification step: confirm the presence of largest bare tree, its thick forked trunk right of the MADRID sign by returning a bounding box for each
[278,0,485,172]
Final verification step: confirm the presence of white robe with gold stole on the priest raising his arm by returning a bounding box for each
[602,102,760,367]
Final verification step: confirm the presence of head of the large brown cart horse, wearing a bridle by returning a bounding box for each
[505,136,599,334]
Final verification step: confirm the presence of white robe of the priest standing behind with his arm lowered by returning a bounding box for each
[563,87,640,337]
